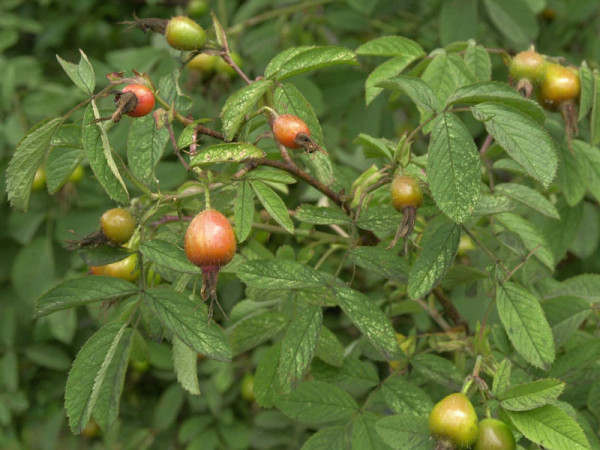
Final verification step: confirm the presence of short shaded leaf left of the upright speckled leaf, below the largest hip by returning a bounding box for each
[229,312,287,355]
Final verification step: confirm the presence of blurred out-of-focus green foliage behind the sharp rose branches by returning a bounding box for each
[0,0,600,449]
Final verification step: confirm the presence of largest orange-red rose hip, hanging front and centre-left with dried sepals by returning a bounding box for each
[185,209,236,270]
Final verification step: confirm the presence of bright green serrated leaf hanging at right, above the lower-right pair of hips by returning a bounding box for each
[496,282,554,369]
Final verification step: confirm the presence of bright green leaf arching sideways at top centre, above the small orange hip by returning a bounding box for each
[265,46,358,81]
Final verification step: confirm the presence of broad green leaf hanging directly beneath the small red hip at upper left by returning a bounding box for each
[127,114,169,184]
